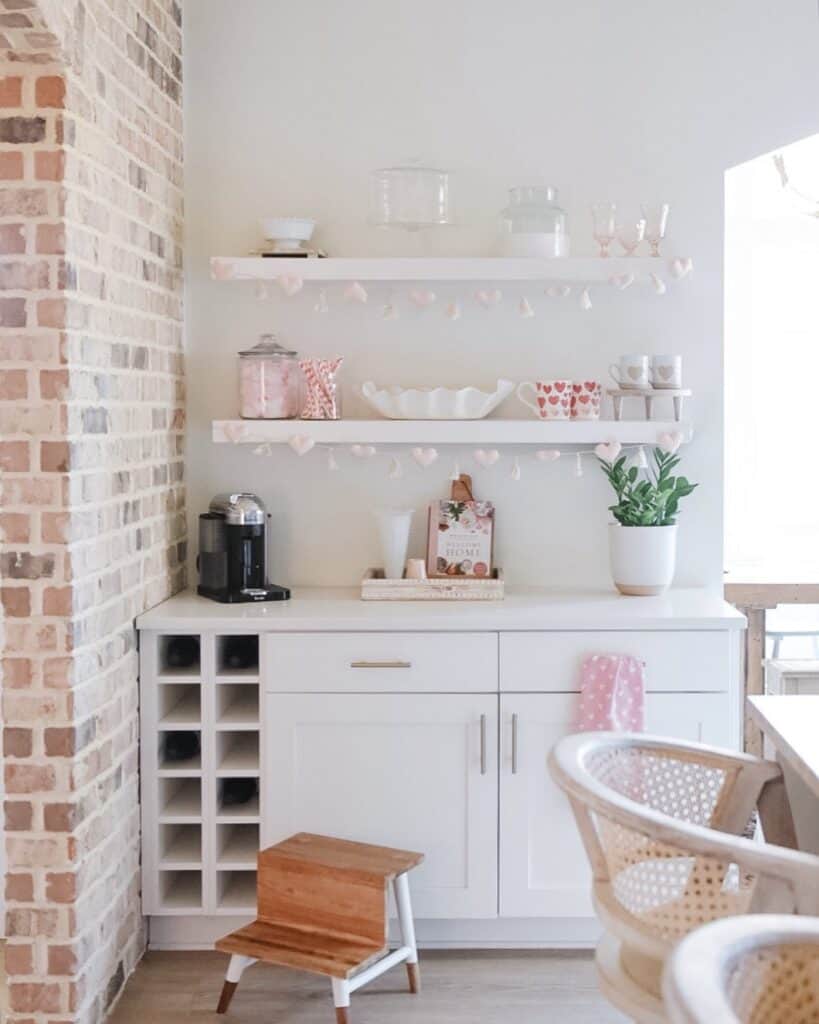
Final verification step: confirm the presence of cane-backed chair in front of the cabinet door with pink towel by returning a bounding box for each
[549,732,819,1024]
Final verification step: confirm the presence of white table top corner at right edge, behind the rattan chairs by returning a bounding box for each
[748,694,819,799]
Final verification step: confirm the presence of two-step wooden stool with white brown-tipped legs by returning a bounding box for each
[216,833,424,1024]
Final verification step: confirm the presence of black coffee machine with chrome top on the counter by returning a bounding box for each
[197,494,290,604]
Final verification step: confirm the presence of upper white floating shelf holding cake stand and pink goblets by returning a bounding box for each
[211,256,690,285]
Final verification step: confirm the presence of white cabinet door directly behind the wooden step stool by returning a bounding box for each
[262,692,498,919]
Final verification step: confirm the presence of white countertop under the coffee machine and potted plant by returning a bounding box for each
[136,587,745,633]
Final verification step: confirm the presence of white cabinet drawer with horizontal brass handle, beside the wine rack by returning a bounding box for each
[263,633,498,693]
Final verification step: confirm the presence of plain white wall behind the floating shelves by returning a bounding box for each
[185,0,819,586]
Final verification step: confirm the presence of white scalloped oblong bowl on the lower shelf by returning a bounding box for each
[361,380,515,420]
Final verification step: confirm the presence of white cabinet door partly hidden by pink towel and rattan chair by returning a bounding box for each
[500,693,730,918]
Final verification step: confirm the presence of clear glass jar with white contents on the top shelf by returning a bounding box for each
[501,185,569,257]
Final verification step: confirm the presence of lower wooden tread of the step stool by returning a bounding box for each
[216,920,387,978]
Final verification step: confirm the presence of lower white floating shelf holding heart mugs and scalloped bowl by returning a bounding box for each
[213,419,693,445]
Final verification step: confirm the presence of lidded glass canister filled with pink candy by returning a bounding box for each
[239,334,301,420]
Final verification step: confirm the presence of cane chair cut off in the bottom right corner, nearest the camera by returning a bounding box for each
[662,913,819,1024]
